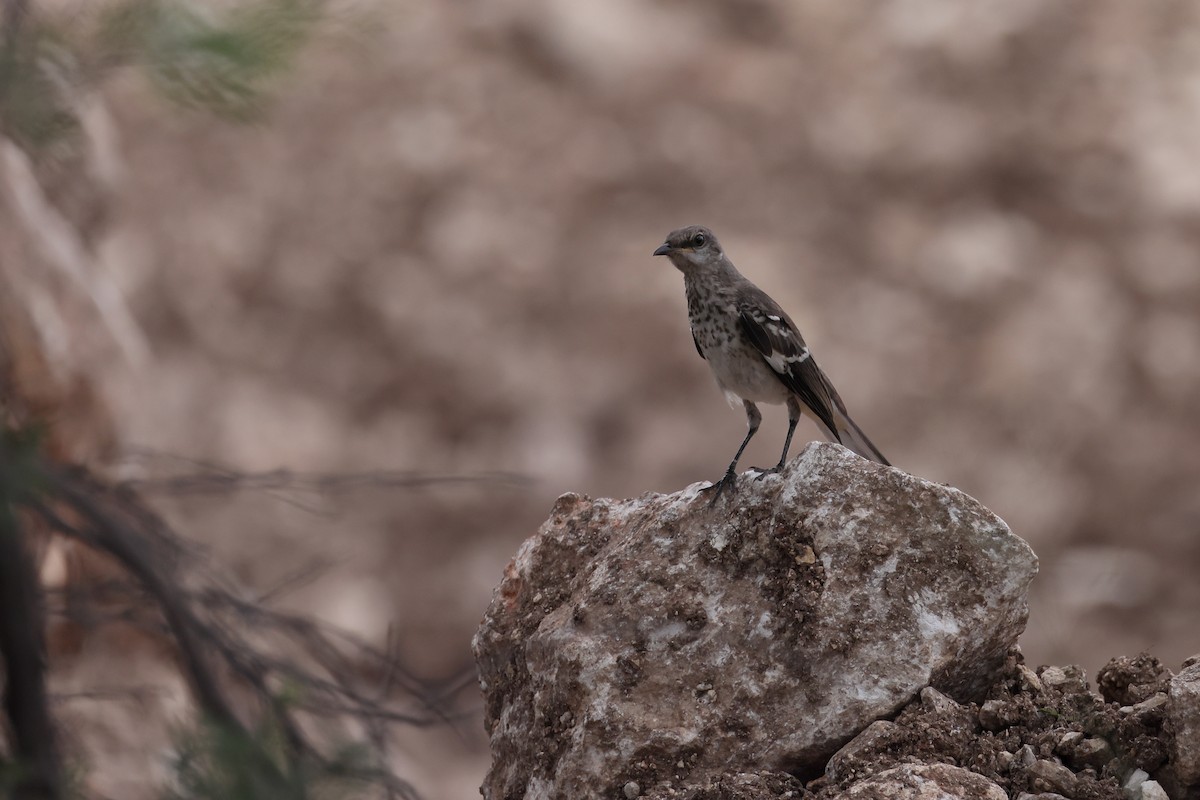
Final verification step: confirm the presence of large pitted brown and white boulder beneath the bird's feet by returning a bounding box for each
[474,443,1037,800]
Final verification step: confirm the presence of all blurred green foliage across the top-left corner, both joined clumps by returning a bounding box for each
[0,0,322,151]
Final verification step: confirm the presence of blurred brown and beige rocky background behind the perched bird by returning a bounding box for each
[0,0,1200,799]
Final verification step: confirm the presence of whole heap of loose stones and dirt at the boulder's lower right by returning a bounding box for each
[649,652,1200,800]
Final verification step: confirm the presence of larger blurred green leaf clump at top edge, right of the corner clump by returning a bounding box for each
[101,0,320,120]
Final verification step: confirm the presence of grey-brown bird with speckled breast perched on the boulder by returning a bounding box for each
[654,225,889,503]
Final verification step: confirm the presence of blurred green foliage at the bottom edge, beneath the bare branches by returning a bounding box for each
[164,721,378,800]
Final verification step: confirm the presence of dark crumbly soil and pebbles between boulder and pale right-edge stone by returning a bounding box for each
[806,654,1184,800]
